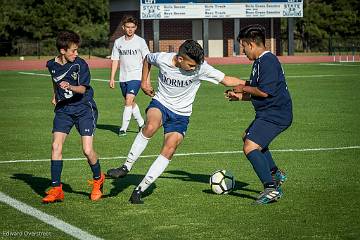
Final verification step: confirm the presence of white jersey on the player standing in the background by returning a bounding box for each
[111,34,150,82]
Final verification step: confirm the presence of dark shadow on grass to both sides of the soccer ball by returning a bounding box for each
[161,170,260,200]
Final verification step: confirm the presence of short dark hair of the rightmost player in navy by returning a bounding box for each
[237,24,265,46]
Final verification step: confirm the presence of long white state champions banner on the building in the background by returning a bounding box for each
[140,0,303,19]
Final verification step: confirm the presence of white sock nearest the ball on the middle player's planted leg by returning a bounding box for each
[137,154,170,192]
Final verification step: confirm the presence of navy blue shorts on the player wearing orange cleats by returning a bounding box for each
[52,101,98,136]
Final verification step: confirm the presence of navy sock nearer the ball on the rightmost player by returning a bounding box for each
[246,149,275,187]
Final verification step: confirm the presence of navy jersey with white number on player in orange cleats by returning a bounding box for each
[46,57,94,105]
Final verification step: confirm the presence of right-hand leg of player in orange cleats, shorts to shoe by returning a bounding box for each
[75,101,105,201]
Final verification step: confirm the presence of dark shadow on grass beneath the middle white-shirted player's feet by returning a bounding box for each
[103,173,156,198]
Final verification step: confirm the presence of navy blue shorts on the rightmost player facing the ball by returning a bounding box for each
[244,118,289,148]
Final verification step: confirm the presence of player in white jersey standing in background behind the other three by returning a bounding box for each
[109,16,150,136]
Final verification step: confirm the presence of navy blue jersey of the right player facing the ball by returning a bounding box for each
[250,51,292,125]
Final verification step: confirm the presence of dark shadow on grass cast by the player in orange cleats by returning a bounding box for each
[11,173,90,197]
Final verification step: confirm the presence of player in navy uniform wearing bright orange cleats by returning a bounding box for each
[42,31,105,203]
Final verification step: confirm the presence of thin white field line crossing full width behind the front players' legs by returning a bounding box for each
[0,146,360,164]
